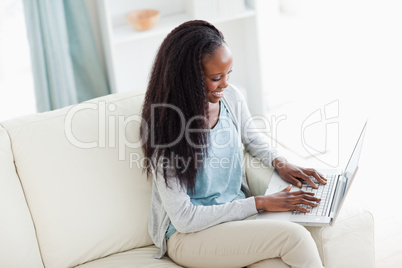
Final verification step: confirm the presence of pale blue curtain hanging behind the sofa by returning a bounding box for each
[23,0,110,112]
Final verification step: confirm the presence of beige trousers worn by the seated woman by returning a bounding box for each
[167,220,323,268]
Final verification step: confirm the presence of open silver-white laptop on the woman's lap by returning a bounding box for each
[257,121,367,226]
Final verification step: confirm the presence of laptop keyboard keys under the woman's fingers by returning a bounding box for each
[292,175,337,216]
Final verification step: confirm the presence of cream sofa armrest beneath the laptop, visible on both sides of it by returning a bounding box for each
[244,154,375,268]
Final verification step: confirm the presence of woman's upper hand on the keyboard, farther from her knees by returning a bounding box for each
[273,157,327,189]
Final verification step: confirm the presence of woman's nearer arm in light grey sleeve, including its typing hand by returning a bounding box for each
[154,161,321,226]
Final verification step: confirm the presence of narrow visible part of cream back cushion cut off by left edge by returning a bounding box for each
[0,126,43,268]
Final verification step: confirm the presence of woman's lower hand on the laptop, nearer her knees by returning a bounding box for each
[254,185,321,213]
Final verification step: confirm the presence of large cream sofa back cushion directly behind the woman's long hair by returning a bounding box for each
[3,93,152,268]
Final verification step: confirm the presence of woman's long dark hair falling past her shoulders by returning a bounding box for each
[140,20,225,191]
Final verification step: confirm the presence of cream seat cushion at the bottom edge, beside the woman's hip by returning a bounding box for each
[76,246,181,268]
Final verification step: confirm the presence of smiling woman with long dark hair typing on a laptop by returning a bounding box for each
[141,21,326,268]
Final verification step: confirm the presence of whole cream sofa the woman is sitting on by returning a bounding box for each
[0,93,374,268]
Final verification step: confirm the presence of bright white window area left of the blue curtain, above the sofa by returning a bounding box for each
[0,0,36,122]
